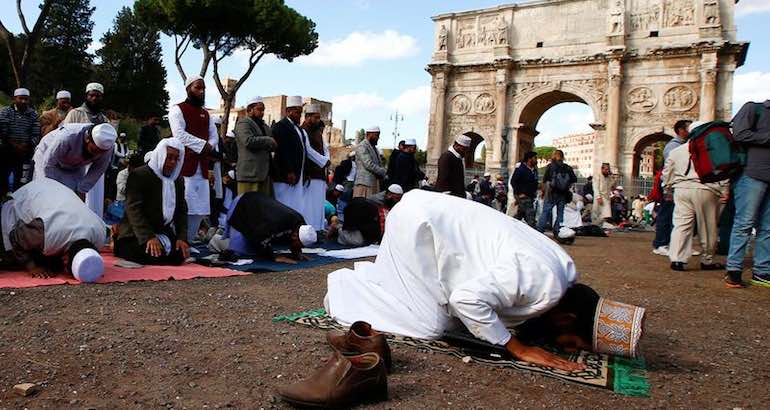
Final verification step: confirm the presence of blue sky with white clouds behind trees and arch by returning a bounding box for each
[10,0,770,148]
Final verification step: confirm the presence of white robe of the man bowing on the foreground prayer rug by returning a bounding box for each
[325,190,578,345]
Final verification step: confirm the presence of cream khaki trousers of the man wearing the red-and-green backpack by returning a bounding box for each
[668,188,722,265]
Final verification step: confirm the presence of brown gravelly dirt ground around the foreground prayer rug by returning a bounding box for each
[0,233,770,409]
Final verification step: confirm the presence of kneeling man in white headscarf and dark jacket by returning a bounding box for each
[115,138,190,265]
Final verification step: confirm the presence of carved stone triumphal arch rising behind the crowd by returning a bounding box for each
[427,0,748,176]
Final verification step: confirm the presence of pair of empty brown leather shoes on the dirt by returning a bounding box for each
[278,321,391,408]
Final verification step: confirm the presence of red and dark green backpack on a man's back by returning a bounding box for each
[687,121,746,184]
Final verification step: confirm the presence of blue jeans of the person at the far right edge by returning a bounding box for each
[727,175,770,275]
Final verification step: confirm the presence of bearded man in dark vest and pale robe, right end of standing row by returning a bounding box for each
[302,104,330,231]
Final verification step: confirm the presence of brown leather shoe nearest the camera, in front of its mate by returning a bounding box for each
[278,351,388,408]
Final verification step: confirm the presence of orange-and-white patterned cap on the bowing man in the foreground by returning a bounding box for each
[593,298,644,357]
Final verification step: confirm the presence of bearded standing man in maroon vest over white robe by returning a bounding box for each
[168,75,221,243]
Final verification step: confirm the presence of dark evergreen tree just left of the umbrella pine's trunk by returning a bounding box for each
[96,7,169,119]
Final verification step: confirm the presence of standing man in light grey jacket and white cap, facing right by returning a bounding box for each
[353,127,388,198]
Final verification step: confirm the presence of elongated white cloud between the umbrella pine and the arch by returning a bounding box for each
[296,30,419,66]
